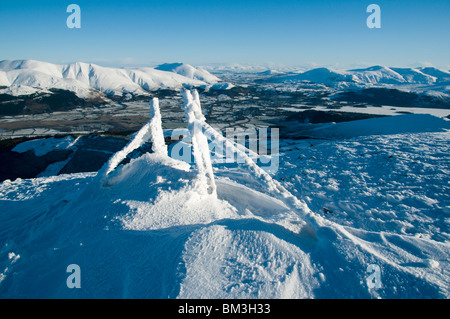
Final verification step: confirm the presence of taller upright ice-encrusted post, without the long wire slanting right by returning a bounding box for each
[181,90,217,195]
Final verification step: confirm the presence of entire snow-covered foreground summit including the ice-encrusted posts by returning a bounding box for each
[0,91,450,298]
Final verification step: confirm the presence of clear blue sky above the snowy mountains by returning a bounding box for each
[0,0,450,68]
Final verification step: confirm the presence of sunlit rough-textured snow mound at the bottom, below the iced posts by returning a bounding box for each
[179,225,318,298]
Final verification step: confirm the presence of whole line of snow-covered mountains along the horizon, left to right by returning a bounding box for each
[0,60,450,98]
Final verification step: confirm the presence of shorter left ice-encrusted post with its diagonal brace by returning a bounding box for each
[98,97,167,182]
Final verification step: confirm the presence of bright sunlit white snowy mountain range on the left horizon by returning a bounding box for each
[0,60,220,98]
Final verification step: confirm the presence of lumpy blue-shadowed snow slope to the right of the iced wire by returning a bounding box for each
[277,132,450,241]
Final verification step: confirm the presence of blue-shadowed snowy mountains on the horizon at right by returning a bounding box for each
[270,65,450,86]
